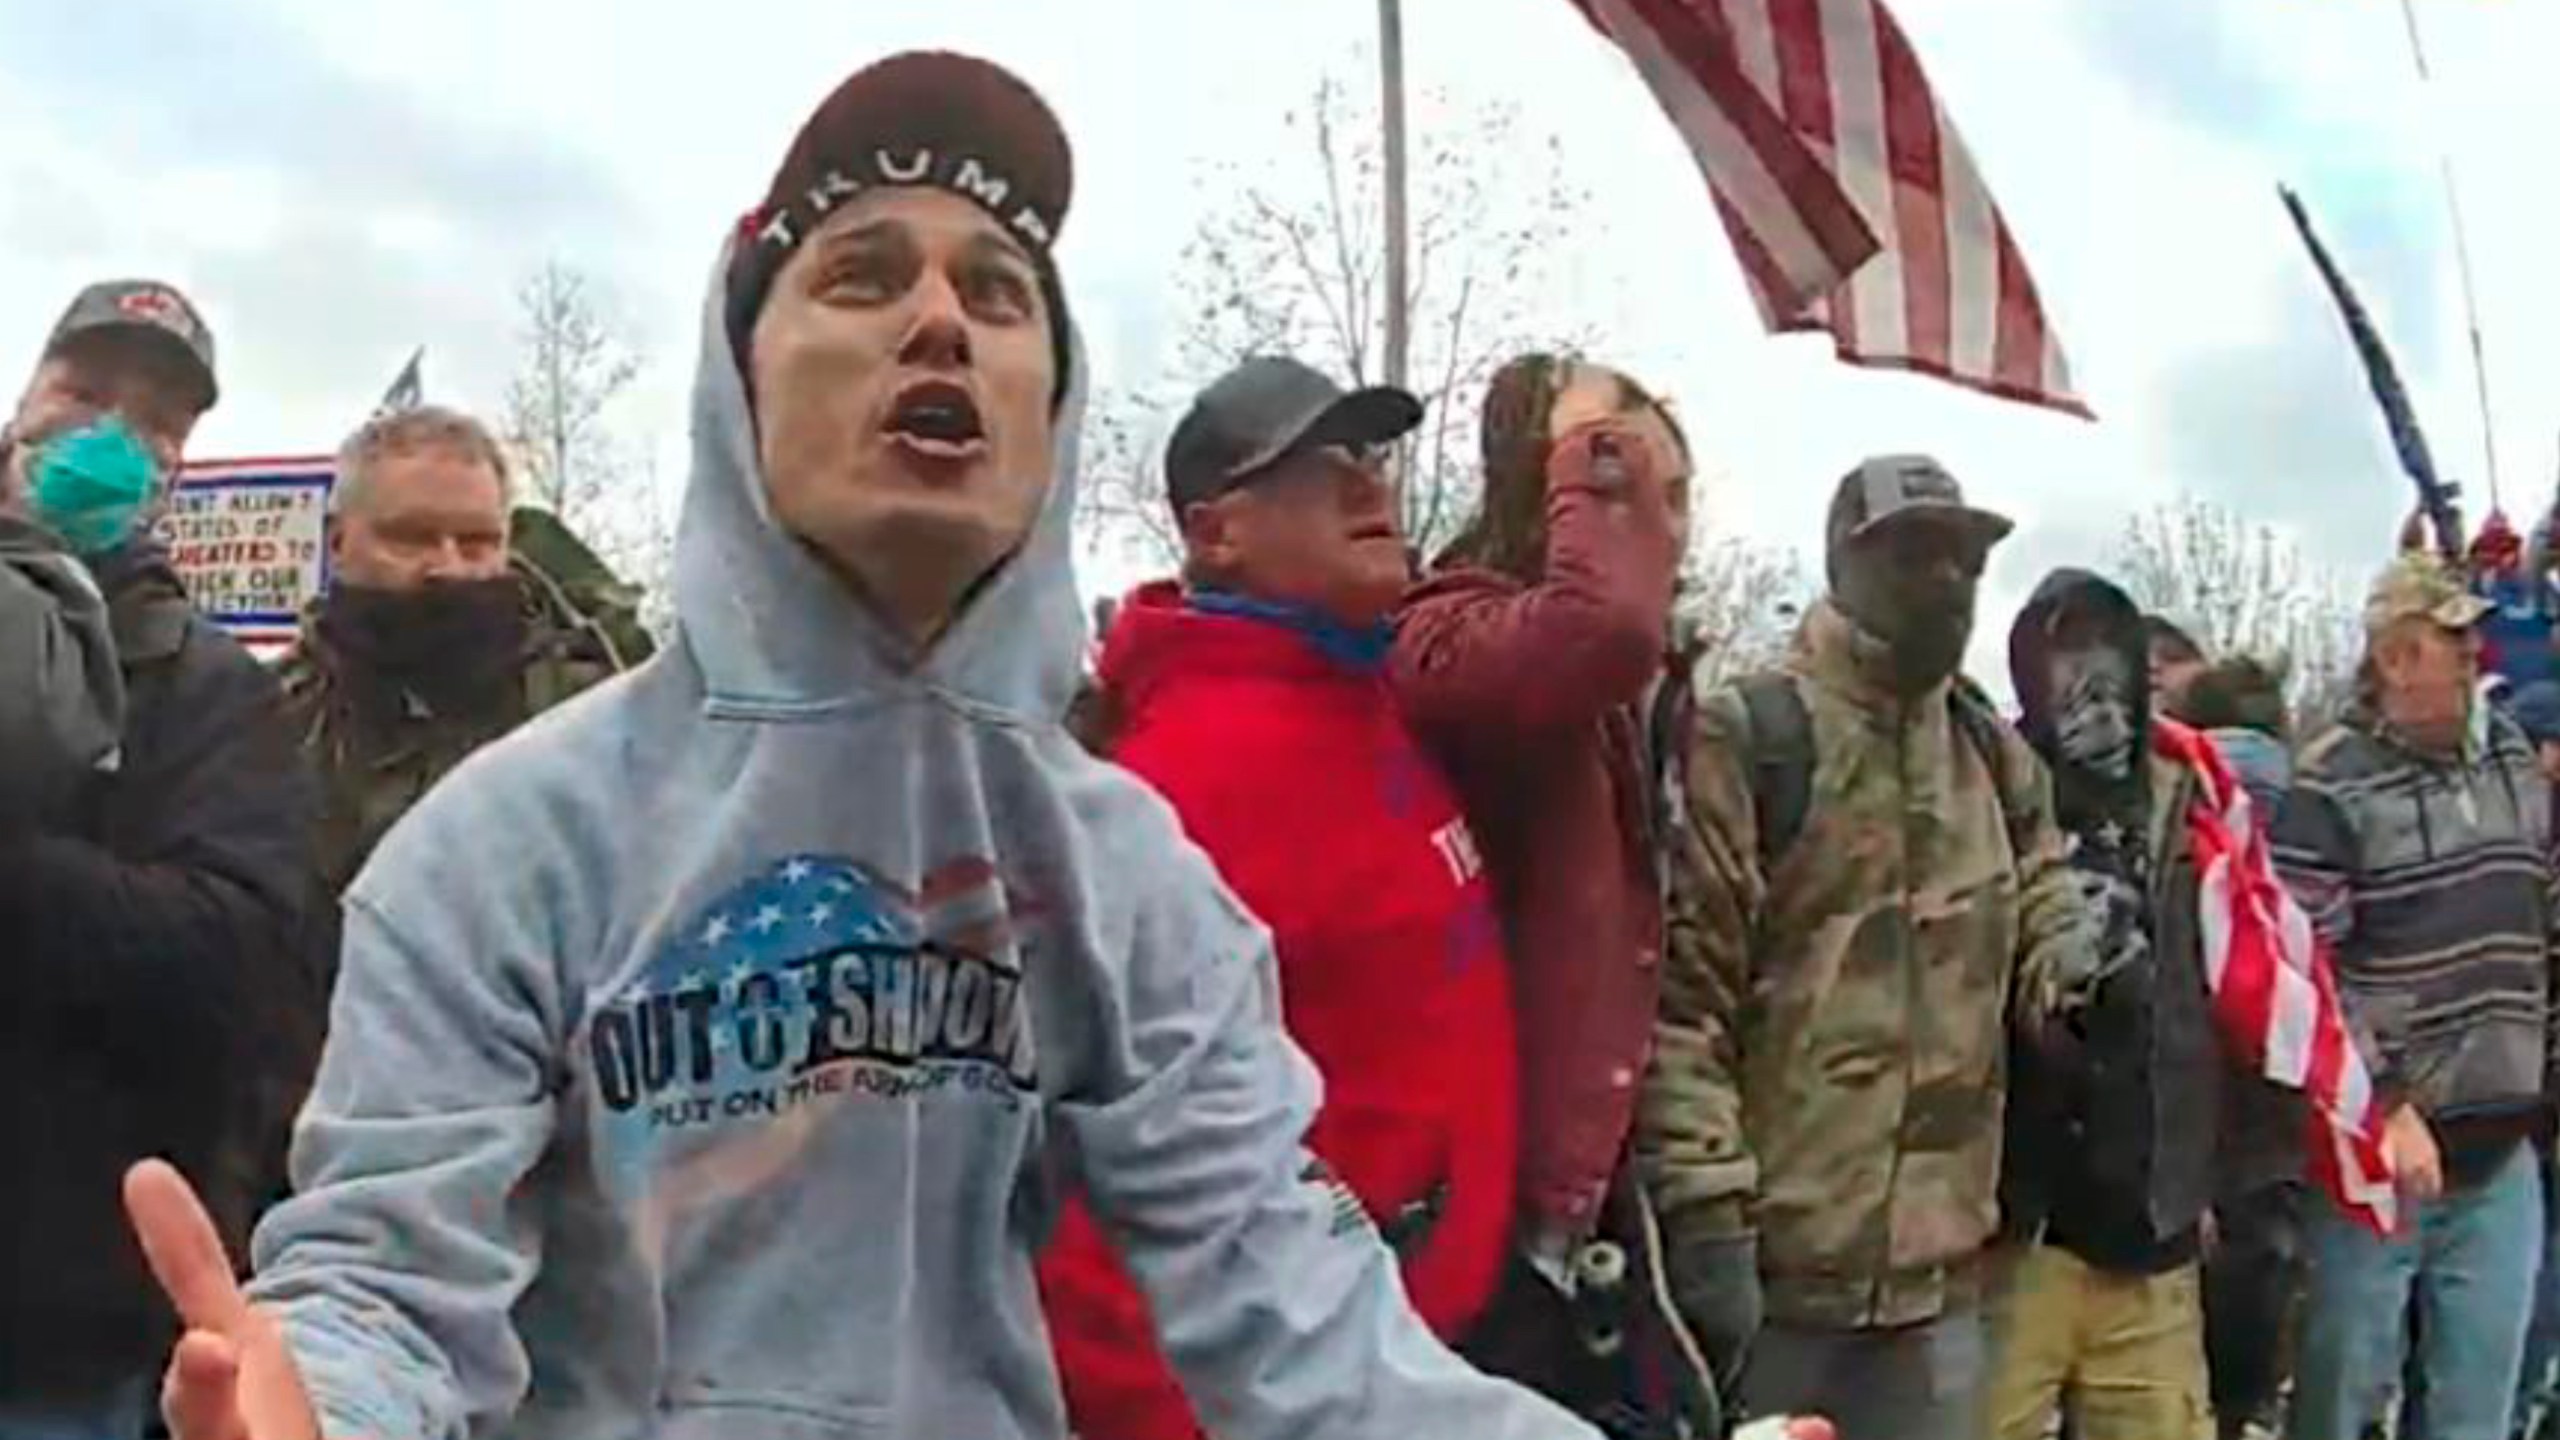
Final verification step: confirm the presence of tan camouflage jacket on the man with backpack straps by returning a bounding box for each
[1636,605,2081,1327]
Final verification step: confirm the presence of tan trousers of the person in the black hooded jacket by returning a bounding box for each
[1987,1245,2214,1440]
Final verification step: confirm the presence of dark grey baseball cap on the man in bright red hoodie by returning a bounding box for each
[1165,356,1423,515]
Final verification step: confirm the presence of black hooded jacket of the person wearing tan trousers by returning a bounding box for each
[2002,569,2227,1273]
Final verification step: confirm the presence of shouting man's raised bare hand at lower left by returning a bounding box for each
[125,1161,320,1440]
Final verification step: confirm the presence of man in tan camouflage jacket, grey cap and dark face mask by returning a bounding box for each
[1638,456,2094,1440]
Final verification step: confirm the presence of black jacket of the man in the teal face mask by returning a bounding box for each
[0,543,325,1399]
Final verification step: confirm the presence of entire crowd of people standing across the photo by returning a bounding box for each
[0,39,2560,1440]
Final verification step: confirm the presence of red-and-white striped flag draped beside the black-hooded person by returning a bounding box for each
[2153,720,2396,1235]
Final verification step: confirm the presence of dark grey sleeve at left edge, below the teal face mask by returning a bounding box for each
[0,512,125,835]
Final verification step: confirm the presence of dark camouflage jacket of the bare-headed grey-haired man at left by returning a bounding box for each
[282,543,648,894]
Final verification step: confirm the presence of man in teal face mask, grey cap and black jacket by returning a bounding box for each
[0,282,320,1440]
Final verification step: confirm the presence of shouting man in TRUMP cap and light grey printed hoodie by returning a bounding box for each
[125,54,1587,1440]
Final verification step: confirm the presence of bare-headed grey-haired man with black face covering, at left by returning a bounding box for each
[282,405,648,896]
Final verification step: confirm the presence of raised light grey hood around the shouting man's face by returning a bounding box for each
[676,238,1085,720]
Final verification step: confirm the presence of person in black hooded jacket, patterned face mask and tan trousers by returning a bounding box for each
[1989,569,2227,1440]
